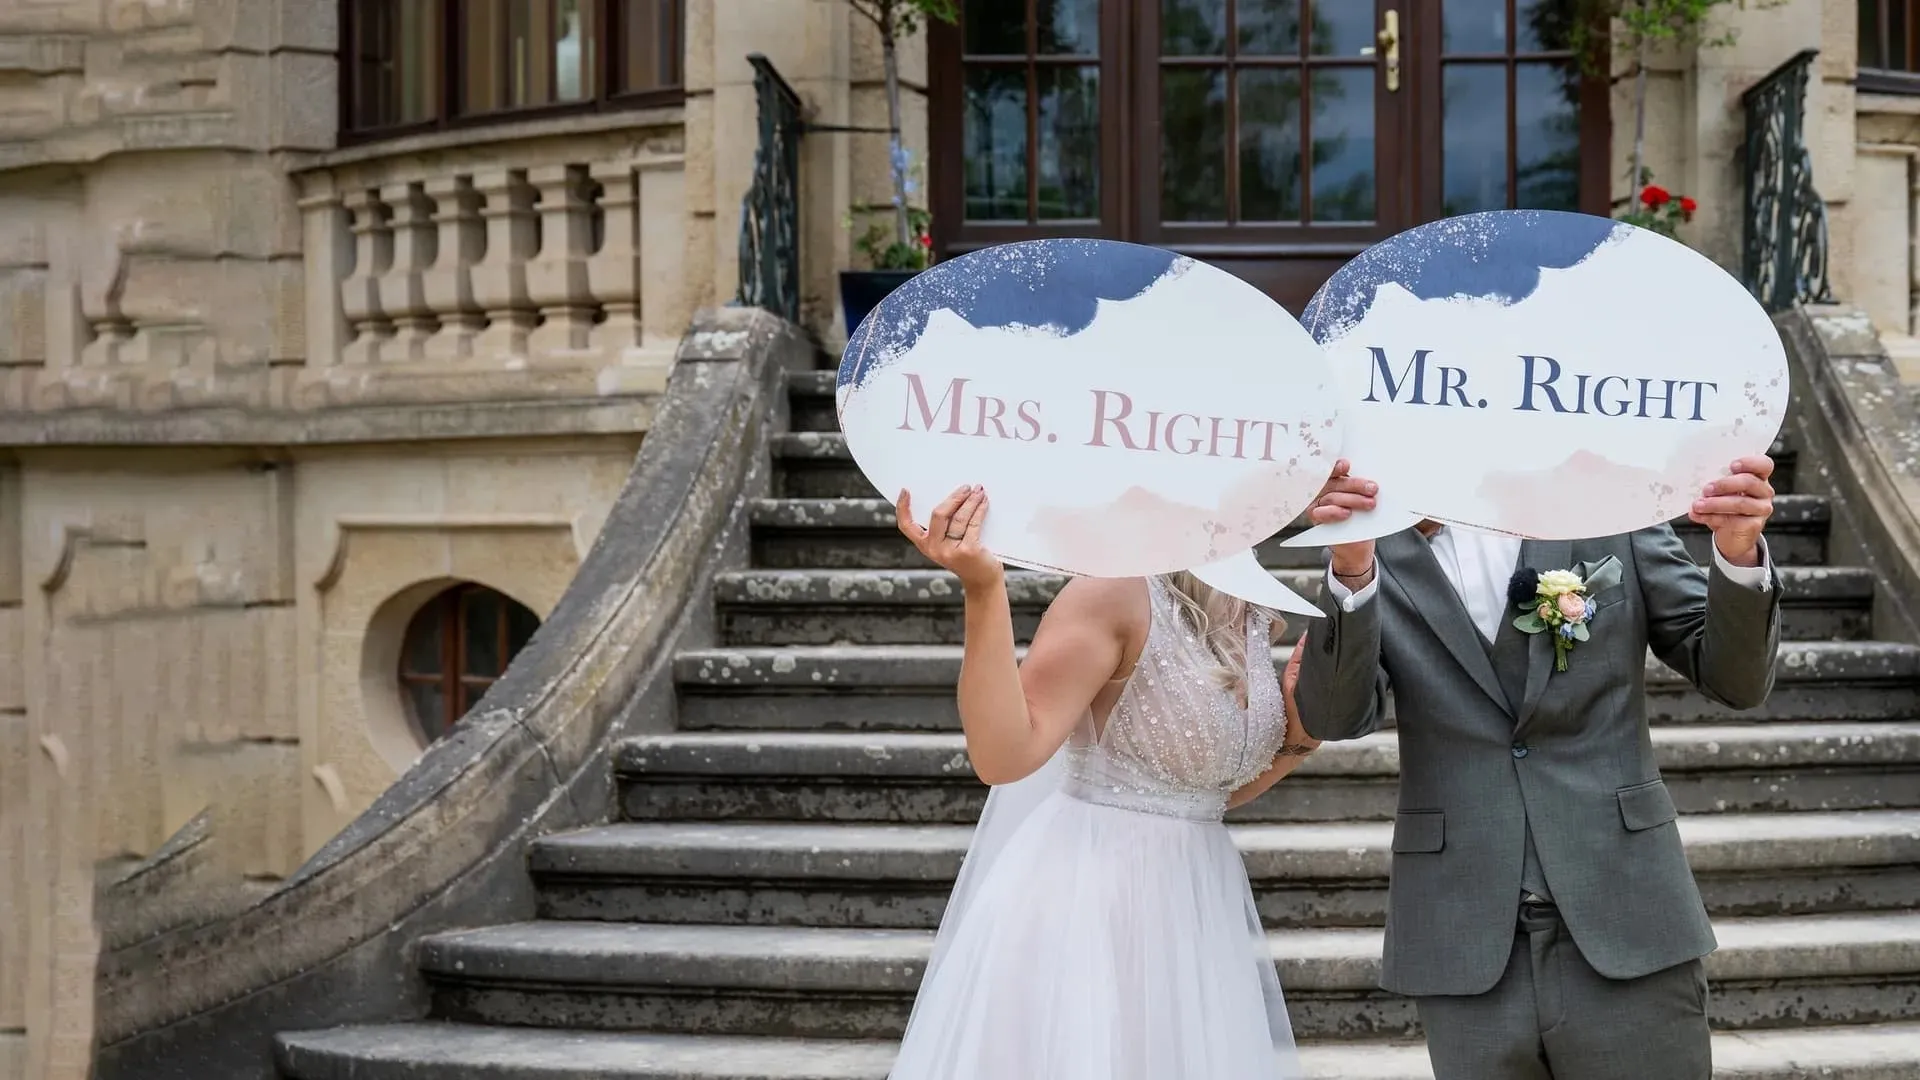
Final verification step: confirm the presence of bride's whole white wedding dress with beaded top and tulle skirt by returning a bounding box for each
[891,578,1300,1080]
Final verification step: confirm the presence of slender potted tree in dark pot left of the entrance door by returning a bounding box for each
[841,0,960,336]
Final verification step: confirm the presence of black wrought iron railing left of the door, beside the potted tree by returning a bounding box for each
[737,52,806,323]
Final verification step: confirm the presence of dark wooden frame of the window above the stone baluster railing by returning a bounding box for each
[336,0,687,146]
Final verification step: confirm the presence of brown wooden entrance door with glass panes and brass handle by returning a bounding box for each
[929,0,1609,311]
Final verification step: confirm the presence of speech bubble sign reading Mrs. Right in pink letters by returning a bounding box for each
[835,240,1340,615]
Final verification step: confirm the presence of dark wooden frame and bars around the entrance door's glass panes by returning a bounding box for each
[927,0,1613,258]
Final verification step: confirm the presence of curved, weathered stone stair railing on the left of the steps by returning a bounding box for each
[94,305,812,1080]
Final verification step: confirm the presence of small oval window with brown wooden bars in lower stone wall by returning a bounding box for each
[399,584,540,744]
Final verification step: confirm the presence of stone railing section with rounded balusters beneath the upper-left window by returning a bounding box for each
[296,113,689,400]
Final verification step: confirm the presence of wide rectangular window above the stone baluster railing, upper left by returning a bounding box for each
[340,0,685,138]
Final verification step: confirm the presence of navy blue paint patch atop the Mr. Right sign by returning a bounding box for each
[1300,209,1628,344]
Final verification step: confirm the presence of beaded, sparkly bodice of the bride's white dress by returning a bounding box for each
[1066,577,1286,821]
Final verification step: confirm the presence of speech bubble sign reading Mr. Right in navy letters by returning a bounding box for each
[1286,209,1788,546]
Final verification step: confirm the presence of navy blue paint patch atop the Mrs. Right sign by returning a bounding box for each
[837,240,1181,386]
